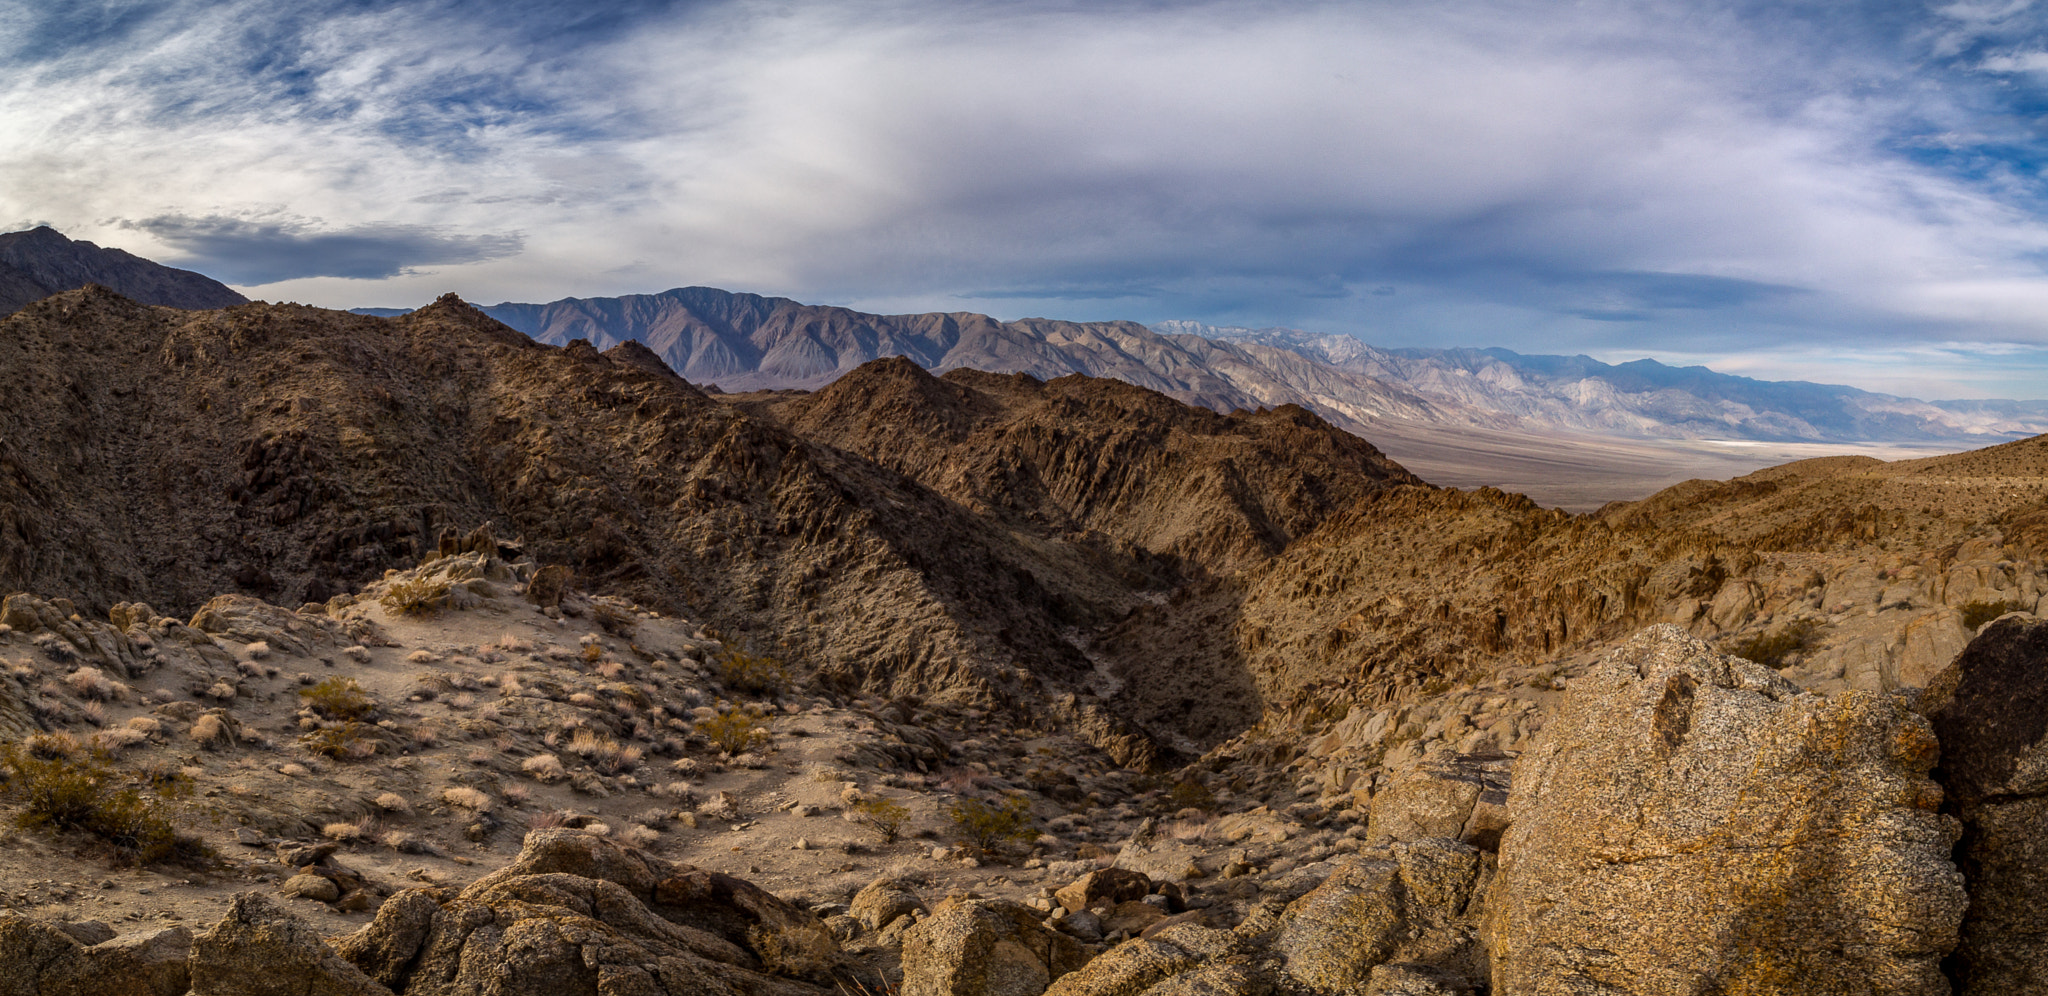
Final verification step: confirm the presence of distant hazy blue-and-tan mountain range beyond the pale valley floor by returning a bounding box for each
[360,287,2048,445]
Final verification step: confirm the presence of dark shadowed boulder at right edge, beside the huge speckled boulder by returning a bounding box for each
[1919,615,2048,996]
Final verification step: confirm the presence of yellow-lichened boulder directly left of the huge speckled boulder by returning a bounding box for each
[1272,838,1485,990]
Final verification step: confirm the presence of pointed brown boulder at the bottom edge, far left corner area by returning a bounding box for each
[190,891,391,996]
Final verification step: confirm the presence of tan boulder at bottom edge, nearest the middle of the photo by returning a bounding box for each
[901,900,1087,996]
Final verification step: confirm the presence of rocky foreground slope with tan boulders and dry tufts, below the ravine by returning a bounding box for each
[0,533,2048,996]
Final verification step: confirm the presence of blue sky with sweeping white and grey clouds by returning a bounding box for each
[0,0,2048,398]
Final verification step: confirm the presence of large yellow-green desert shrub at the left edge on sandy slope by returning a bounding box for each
[0,744,205,865]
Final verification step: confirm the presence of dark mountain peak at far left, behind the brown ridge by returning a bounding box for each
[0,225,248,316]
